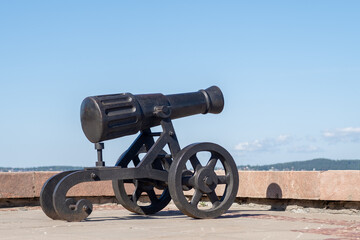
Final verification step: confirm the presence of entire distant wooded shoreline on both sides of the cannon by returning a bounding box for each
[0,158,360,172]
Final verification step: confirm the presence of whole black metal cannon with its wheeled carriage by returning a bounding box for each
[40,86,239,221]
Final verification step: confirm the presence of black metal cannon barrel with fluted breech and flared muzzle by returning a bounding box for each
[80,86,224,143]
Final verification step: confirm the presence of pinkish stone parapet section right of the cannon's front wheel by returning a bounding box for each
[237,170,360,201]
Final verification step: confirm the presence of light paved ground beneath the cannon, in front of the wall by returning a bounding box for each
[0,204,360,240]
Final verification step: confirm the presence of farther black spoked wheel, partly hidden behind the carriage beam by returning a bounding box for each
[113,151,171,215]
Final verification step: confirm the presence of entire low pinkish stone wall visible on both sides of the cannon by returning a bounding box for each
[0,171,360,202]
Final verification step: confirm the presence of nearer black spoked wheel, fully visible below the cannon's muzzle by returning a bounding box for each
[169,143,239,218]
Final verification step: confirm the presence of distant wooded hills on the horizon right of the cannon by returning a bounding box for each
[238,158,360,171]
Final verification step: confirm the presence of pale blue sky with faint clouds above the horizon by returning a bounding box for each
[0,0,360,167]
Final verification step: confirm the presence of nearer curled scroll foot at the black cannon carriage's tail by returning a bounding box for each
[53,171,94,222]
